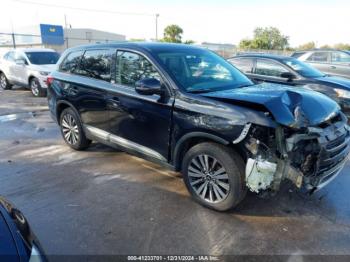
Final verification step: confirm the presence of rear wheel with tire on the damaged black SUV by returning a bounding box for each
[60,108,91,150]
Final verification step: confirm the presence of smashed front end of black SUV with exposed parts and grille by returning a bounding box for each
[238,112,350,193]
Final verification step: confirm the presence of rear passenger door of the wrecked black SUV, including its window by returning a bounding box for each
[56,49,115,131]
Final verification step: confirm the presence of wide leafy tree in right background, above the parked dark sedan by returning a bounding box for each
[239,27,289,50]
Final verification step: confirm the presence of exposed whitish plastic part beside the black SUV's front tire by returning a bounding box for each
[245,158,277,193]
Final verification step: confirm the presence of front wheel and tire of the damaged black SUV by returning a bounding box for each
[182,142,247,211]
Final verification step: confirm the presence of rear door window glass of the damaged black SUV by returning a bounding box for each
[76,50,115,82]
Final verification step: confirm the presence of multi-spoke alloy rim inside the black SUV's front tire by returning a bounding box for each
[188,154,230,203]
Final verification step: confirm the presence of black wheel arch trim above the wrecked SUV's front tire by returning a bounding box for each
[172,132,230,171]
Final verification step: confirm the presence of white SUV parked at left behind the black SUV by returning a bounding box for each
[0,49,59,96]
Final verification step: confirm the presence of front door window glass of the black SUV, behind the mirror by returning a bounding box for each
[116,51,160,87]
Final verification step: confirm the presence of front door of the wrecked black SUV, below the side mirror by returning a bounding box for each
[107,50,174,161]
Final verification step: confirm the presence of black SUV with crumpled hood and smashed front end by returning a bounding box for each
[48,43,350,210]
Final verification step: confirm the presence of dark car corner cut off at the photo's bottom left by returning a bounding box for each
[0,196,47,262]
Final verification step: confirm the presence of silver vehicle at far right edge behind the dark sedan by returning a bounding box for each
[292,49,350,78]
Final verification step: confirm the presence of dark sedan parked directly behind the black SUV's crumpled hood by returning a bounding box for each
[228,54,350,118]
